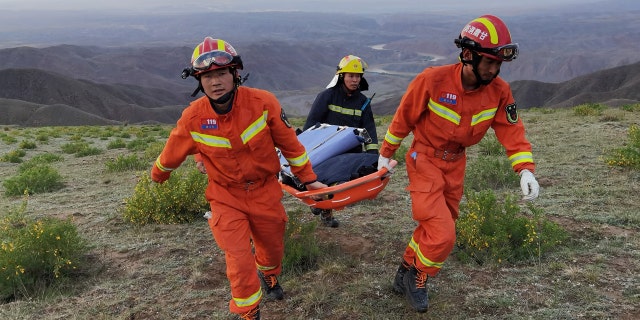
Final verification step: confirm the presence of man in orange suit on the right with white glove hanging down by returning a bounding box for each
[378,15,539,312]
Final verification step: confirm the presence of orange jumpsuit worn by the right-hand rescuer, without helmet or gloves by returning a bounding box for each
[380,63,535,276]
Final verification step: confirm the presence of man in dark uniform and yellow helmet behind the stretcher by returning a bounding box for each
[303,55,378,228]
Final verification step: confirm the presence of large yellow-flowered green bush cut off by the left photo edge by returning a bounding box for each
[0,200,88,301]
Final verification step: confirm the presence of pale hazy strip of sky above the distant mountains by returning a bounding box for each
[0,0,604,13]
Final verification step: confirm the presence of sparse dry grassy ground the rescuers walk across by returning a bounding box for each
[0,108,640,320]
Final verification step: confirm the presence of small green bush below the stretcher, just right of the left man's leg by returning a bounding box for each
[282,210,321,273]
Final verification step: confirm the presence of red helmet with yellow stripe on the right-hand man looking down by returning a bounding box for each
[455,15,518,61]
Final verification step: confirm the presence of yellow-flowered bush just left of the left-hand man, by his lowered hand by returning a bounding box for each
[122,166,209,225]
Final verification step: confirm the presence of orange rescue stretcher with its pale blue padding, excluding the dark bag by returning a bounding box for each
[279,124,397,210]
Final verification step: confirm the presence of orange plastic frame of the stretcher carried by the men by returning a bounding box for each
[280,160,398,210]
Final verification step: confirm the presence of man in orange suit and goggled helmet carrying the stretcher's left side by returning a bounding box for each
[151,37,326,319]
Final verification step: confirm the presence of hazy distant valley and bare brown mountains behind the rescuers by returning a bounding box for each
[0,1,640,126]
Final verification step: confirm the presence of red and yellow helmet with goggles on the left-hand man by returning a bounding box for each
[191,37,242,76]
